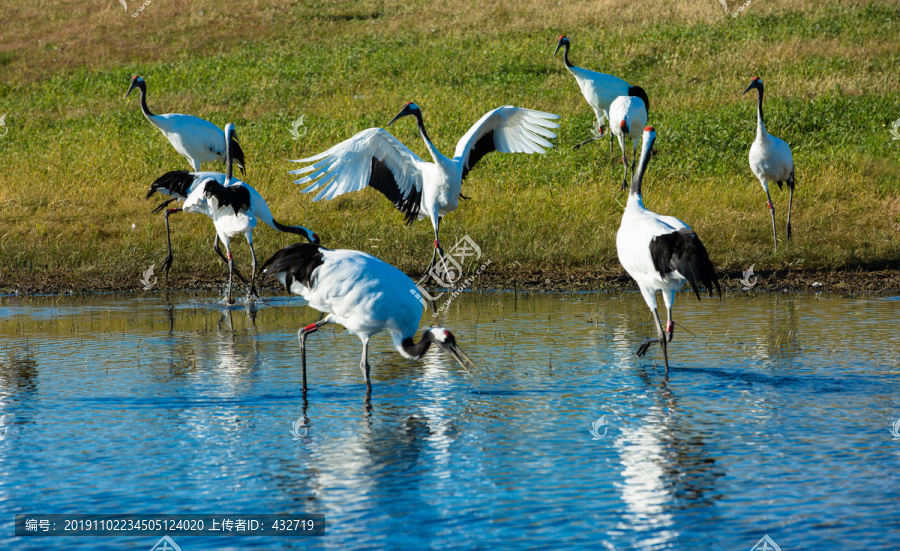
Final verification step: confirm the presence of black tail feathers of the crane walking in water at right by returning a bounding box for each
[650,228,722,300]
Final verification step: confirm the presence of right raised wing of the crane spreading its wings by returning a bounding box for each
[453,105,559,178]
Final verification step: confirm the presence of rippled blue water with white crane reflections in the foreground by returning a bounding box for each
[0,293,900,551]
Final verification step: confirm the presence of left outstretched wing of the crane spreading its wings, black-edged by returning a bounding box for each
[289,128,424,220]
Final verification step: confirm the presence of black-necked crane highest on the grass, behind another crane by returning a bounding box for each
[553,35,650,151]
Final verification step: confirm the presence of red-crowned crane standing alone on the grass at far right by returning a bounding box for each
[741,77,794,251]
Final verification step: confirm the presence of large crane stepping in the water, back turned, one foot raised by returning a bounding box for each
[616,126,722,373]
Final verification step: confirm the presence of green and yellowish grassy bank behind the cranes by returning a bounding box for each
[0,0,900,290]
